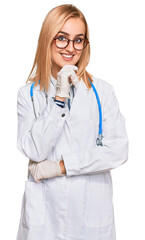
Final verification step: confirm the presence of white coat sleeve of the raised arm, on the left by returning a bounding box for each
[17,88,66,162]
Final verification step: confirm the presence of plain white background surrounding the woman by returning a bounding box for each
[0,0,145,240]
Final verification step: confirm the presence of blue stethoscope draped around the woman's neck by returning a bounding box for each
[30,78,103,146]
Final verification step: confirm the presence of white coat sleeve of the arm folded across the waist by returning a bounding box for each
[62,85,128,176]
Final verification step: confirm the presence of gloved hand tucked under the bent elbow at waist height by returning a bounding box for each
[28,160,65,183]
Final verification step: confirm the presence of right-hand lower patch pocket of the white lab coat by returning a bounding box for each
[85,177,113,227]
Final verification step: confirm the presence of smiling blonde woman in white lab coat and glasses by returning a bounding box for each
[17,4,128,240]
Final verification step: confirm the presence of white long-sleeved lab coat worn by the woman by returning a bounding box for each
[17,77,128,240]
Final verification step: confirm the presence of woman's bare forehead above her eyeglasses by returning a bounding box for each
[60,18,86,36]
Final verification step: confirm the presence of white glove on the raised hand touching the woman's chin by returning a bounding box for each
[56,65,78,98]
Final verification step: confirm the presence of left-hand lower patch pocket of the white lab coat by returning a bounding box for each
[22,181,46,227]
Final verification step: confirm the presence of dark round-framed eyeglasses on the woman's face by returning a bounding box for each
[53,35,89,51]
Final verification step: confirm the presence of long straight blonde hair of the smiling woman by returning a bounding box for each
[26,4,93,91]
